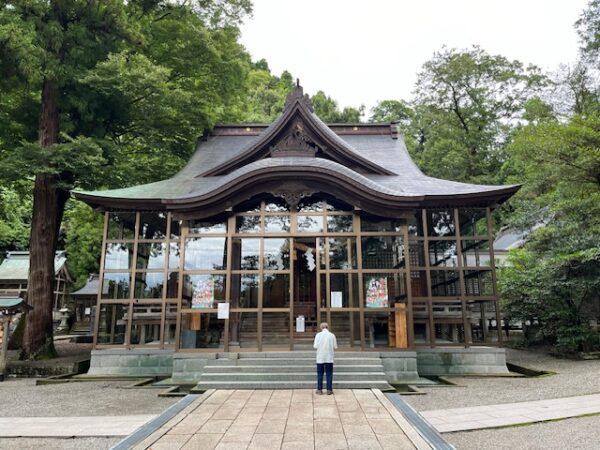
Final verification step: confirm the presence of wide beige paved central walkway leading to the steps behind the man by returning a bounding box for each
[124,389,431,450]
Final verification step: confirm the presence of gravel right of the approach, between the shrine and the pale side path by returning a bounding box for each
[403,349,600,411]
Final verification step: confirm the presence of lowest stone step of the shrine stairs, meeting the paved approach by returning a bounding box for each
[190,380,394,394]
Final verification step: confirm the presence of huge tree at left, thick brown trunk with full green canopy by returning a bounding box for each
[0,0,249,356]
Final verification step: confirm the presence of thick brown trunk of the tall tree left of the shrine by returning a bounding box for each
[22,80,68,358]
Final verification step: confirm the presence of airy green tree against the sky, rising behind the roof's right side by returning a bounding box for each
[412,47,546,183]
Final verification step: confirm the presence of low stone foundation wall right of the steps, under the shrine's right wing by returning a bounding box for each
[417,347,508,376]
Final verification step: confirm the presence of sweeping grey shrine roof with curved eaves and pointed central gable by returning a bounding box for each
[73,88,519,216]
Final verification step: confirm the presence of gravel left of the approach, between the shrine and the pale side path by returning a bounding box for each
[0,379,179,417]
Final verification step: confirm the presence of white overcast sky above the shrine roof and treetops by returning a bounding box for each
[241,0,587,112]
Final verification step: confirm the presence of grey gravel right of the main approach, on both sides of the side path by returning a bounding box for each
[403,349,600,450]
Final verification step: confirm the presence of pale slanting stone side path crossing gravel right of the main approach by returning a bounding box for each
[420,394,600,433]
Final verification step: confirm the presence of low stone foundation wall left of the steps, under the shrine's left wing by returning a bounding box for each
[88,348,174,377]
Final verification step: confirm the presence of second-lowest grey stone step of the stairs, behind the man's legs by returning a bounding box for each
[200,370,386,382]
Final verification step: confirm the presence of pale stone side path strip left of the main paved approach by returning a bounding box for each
[0,415,155,437]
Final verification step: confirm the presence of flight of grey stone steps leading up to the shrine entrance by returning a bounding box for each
[194,351,392,391]
